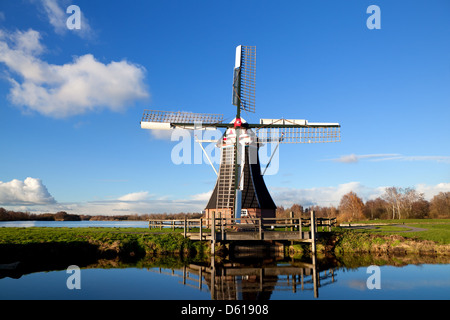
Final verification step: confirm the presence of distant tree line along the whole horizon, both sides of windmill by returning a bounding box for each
[0,187,450,221]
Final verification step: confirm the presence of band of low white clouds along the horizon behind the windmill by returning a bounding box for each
[4,178,450,215]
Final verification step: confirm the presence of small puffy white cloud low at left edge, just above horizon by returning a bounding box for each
[0,177,56,206]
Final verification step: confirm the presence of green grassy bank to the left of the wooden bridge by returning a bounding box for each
[0,227,209,263]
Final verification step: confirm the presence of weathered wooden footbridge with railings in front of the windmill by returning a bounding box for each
[149,211,336,253]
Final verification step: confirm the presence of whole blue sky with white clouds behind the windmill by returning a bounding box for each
[0,0,450,215]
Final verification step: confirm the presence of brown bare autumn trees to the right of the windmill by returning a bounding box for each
[277,187,450,221]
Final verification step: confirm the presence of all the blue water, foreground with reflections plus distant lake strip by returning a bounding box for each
[0,221,450,300]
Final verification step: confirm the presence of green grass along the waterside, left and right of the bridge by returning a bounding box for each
[0,219,450,256]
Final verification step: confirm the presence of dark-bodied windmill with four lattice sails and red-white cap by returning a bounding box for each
[141,45,340,222]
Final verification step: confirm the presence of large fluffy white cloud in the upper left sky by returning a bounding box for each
[0,29,149,118]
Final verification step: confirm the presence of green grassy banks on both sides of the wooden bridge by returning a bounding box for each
[0,219,450,264]
